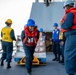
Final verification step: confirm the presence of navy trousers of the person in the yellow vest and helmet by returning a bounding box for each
[1,41,13,62]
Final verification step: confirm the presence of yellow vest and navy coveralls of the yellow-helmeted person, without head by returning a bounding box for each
[1,26,16,63]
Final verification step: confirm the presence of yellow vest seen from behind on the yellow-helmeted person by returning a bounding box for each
[1,27,13,42]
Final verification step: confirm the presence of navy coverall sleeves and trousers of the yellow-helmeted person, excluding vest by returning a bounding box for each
[1,26,16,62]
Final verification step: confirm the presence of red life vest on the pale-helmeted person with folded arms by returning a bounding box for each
[61,7,76,32]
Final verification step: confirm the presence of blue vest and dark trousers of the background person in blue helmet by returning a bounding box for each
[52,29,60,60]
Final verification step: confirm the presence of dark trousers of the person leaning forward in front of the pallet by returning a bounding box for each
[23,45,35,73]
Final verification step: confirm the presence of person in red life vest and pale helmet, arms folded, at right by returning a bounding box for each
[61,0,76,75]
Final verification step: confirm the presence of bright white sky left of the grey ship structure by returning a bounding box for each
[0,0,63,38]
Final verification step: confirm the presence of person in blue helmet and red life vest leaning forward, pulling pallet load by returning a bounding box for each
[21,19,39,75]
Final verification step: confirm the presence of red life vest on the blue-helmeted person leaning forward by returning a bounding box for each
[23,26,39,46]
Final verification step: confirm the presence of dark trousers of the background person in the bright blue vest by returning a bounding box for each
[52,43,60,59]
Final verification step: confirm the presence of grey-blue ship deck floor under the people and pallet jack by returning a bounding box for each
[0,52,67,75]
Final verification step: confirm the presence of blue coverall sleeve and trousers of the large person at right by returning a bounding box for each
[61,12,76,74]
